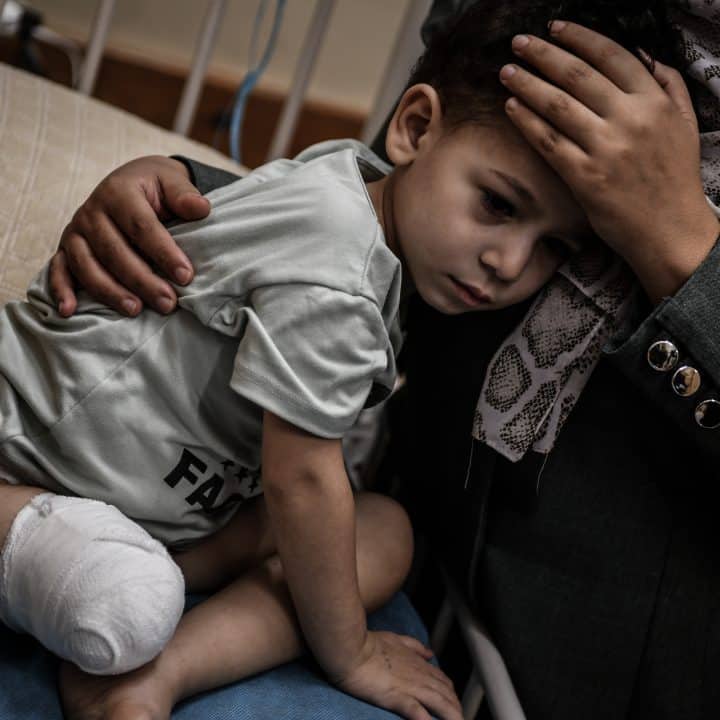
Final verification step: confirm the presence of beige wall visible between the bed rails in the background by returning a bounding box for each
[26,0,408,112]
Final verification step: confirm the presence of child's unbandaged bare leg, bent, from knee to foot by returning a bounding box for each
[61,495,412,720]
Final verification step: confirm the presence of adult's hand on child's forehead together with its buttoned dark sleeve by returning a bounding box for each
[500,22,720,456]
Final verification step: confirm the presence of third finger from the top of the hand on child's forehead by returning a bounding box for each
[500,65,605,151]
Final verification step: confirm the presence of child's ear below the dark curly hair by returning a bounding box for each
[385,83,442,166]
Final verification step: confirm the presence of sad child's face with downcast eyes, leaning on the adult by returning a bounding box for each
[375,83,591,314]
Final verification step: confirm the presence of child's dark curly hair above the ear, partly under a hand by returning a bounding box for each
[409,0,680,127]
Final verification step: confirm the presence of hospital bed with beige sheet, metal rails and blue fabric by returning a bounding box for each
[0,0,524,720]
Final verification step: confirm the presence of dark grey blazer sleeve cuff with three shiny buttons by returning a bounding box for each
[604,241,720,457]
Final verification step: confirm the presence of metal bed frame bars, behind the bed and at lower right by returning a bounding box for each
[0,0,525,720]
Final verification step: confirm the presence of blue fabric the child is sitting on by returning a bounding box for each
[0,594,427,720]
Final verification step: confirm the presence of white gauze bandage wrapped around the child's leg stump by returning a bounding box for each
[0,493,185,675]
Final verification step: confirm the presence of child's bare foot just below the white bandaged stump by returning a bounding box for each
[59,662,173,720]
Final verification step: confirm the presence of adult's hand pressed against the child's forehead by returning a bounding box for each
[500,21,718,299]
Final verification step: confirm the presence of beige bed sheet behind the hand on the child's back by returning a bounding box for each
[0,63,242,306]
